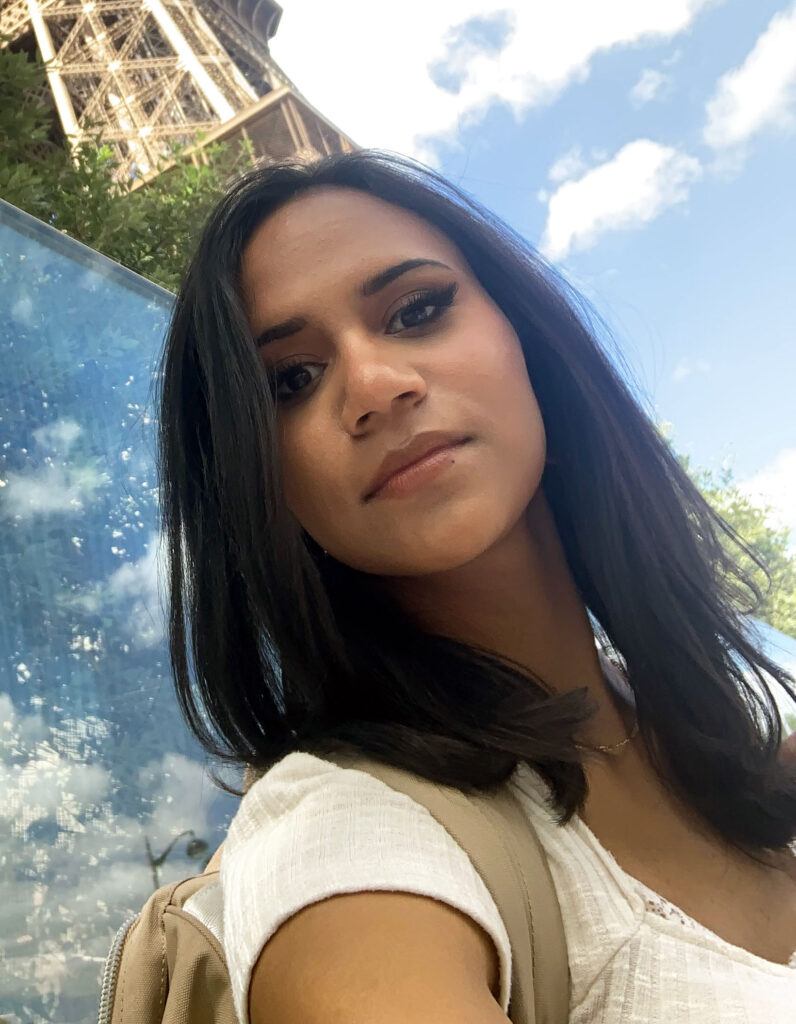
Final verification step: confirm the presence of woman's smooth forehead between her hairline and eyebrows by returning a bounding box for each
[241,186,458,309]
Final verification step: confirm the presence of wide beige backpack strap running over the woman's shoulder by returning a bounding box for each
[325,755,570,1024]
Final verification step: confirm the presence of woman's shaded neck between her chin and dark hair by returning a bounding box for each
[388,488,632,744]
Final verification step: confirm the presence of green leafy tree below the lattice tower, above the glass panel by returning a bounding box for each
[0,48,254,291]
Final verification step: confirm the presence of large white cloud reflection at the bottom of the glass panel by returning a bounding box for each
[0,692,221,1007]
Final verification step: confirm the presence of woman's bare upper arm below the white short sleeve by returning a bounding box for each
[249,892,508,1024]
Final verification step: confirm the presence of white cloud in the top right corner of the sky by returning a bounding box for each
[704,3,796,148]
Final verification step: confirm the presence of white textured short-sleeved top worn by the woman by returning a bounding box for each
[200,753,796,1024]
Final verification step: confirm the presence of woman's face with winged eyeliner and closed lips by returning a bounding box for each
[242,186,545,577]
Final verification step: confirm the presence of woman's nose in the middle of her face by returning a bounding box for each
[338,337,427,435]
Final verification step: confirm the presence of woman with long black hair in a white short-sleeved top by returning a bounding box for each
[156,152,796,1024]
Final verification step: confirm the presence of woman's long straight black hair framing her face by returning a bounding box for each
[159,151,796,853]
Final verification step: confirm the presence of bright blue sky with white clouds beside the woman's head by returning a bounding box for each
[271,0,796,550]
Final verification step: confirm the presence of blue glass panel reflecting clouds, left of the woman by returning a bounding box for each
[0,202,237,1024]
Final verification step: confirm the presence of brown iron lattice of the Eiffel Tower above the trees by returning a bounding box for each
[0,0,354,184]
